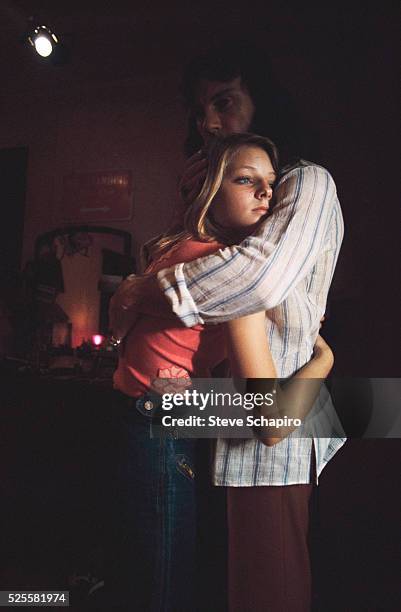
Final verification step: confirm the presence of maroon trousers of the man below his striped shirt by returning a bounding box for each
[227,484,313,612]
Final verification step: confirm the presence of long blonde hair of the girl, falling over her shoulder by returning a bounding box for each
[143,133,279,264]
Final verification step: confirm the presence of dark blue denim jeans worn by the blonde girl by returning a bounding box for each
[106,393,196,612]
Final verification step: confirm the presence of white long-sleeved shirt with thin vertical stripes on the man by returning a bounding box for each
[158,161,345,486]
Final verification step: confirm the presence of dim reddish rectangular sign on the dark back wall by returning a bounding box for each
[61,170,132,223]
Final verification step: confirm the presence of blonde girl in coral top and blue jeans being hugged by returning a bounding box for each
[108,134,333,612]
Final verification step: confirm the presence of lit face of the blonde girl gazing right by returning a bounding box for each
[210,146,276,234]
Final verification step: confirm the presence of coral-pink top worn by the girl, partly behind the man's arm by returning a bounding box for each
[114,239,226,397]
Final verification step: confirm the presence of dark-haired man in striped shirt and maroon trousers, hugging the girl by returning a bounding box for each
[112,47,344,612]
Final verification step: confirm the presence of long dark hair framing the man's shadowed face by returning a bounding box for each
[181,41,309,163]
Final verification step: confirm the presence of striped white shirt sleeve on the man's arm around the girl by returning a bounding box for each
[158,165,338,327]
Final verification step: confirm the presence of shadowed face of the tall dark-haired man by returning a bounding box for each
[194,77,255,143]
